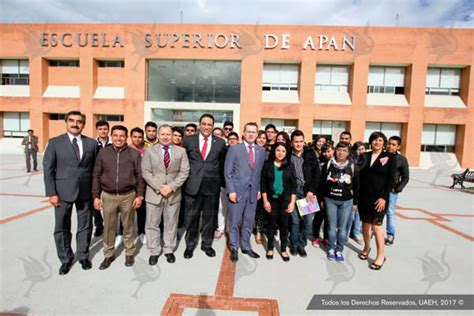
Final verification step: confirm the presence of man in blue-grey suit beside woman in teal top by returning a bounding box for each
[224,123,265,262]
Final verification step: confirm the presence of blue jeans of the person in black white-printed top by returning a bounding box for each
[324,198,353,252]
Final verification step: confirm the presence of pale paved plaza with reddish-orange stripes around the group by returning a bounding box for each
[0,154,474,315]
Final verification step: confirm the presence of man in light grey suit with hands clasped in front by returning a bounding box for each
[142,124,189,265]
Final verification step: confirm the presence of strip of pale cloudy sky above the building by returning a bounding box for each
[0,0,474,28]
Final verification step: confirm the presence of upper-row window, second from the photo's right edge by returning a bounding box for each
[367,66,405,94]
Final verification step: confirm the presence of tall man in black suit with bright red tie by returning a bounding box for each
[184,114,227,259]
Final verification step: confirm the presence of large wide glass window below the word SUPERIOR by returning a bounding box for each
[148,60,240,103]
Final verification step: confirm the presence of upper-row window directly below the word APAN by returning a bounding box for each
[315,65,349,92]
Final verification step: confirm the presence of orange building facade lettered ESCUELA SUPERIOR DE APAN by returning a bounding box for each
[0,24,474,168]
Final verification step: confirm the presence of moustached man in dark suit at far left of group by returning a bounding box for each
[43,111,97,275]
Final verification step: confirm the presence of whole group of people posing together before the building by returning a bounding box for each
[42,111,409,274]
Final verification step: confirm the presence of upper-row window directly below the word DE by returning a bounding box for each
[262,64,299,91]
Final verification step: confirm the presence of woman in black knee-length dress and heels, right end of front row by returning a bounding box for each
[359,132,395,270]
